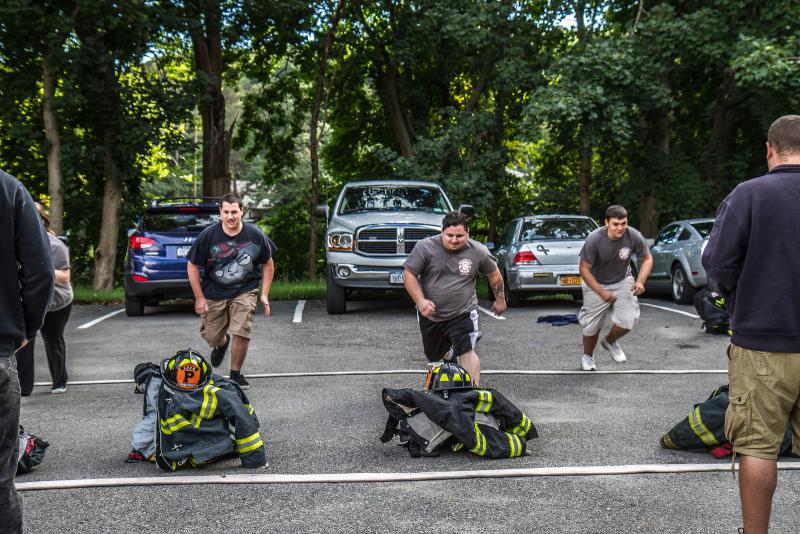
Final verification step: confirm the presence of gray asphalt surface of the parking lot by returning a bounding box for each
[17,298,800,533]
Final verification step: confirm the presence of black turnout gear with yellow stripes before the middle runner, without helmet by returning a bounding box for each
[381,388,538,458]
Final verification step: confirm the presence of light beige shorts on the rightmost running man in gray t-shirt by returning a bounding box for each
[578,276,639,336]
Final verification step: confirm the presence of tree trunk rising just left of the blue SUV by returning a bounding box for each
[93,141,122,291]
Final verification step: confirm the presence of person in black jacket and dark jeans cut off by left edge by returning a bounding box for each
[0,171,55,534]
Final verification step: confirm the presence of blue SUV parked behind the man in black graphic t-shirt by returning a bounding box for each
[124,198,220,316]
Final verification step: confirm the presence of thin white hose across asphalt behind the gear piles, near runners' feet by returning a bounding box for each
[33,369,728,387]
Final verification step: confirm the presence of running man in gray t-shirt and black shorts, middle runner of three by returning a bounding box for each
[403,211,506,386]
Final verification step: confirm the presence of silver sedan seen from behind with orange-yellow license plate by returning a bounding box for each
[490,215,597,306]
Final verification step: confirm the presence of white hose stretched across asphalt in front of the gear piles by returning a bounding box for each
[16,462,800,491]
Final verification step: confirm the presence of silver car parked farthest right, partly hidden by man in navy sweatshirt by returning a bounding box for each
[633,219,714,304]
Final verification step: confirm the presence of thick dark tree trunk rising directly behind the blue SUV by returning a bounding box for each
[186,1,231,197]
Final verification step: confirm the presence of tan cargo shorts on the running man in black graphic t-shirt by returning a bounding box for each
[200,289,258,347]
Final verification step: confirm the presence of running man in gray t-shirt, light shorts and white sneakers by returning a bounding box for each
[578,205,653,371]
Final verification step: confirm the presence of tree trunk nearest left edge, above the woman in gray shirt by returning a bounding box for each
[42,54,64,235]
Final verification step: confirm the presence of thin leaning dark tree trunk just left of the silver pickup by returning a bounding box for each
[308,0,345,280]
